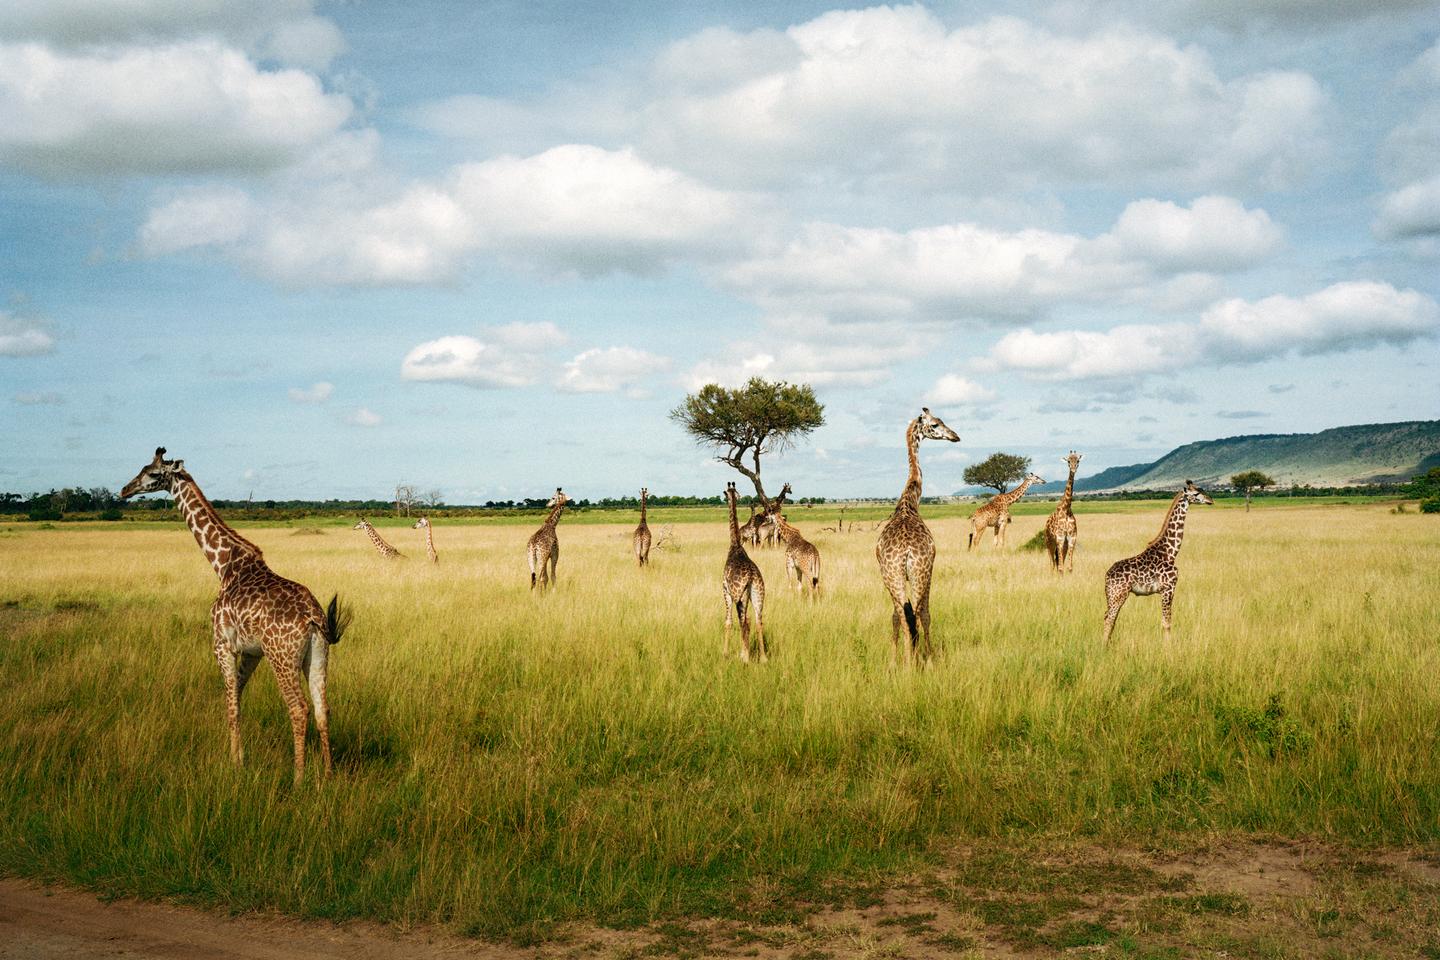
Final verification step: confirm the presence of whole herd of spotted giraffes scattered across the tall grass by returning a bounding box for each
[120,428,1214,783]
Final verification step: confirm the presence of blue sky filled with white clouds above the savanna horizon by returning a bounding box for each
[0,0,1440,504]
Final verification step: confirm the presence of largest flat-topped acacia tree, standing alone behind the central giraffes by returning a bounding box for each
[670,377,825,510]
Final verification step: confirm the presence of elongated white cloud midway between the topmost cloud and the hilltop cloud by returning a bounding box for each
[723,196,1283,321]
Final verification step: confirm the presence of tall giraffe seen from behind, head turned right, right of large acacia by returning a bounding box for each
[876,407,960,664]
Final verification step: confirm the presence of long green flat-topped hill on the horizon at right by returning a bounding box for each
[961,420,1440,494]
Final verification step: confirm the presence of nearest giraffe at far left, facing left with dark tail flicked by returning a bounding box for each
[120,446,350,783]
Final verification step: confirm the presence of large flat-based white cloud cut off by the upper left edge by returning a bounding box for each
[0,40,351,176]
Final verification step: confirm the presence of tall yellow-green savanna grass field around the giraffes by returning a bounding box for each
[0,499,1440,956]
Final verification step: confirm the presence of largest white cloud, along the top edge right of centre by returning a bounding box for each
[445,6,1325,191]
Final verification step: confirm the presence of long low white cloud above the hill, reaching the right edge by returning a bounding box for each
[986,281,1440,380]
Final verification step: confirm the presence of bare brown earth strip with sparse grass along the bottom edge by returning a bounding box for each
[0,839,1440,960]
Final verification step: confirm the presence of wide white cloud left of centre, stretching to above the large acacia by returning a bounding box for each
[140,144,737,285]
